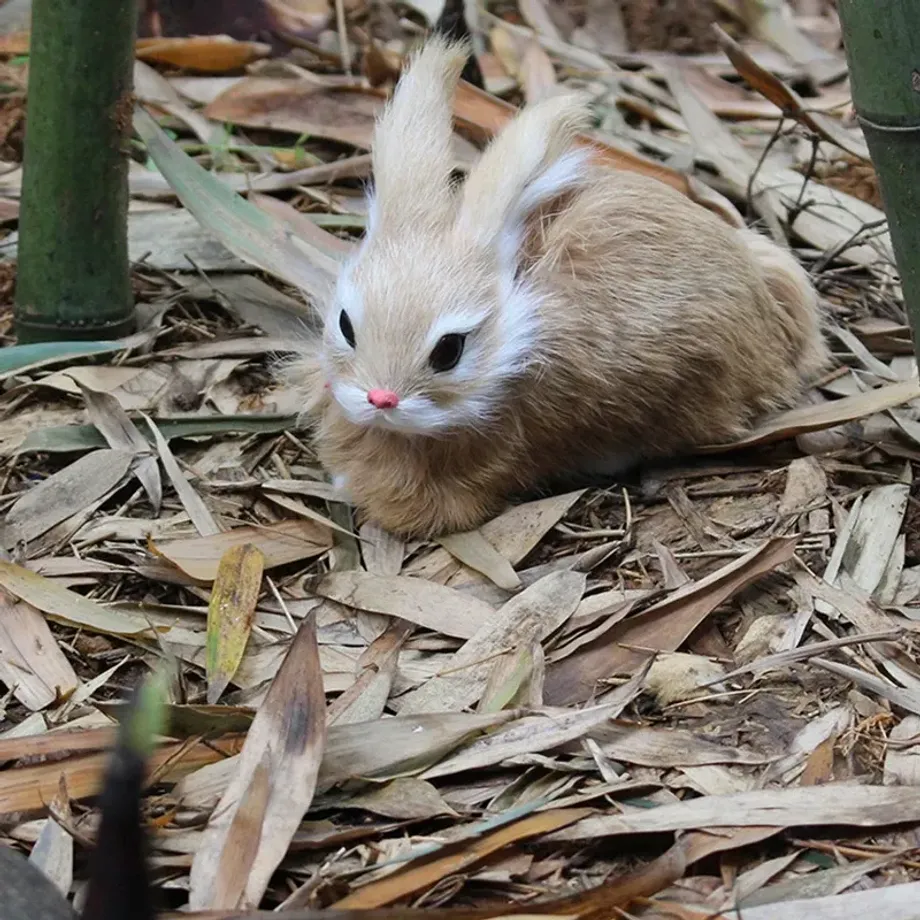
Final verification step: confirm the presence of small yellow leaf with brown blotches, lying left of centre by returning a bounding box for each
[205,543,265,705]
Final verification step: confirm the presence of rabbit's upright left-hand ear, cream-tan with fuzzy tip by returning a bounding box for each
[368,35,469,232]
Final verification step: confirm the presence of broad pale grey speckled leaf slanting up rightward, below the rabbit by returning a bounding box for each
[398,571,586,715]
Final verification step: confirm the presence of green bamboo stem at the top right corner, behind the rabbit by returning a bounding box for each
[837,0,920,365]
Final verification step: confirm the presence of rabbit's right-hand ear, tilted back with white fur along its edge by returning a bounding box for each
[457,93,591,272]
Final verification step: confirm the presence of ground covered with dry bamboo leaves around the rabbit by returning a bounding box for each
[0,0,920,920]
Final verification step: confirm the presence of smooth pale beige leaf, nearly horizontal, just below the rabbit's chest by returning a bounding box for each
[313,571,495,639]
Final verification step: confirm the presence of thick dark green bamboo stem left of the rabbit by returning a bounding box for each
[15,0,137,342]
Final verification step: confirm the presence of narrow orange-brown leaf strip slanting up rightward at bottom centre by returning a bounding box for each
[331,808,591,910]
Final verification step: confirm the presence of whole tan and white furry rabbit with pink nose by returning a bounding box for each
[280,40,828,536]
